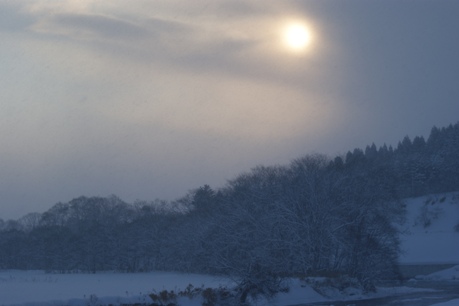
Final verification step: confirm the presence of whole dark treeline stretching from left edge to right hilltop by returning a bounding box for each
[0,123,459,288]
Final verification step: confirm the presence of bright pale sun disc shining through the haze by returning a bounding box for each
[282,22,311,52]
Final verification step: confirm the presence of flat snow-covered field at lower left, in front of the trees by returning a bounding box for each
[0,270,231,306]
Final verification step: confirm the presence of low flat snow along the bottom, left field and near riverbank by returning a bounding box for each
[0,266,450,306]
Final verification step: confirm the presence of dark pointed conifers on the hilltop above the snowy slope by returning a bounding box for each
[334,123,459,198]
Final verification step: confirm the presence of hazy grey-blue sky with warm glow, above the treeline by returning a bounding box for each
[0,0,459,219]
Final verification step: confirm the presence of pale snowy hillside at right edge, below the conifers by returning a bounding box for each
[400,192,459,264]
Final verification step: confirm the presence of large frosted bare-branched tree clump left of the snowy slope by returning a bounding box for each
[198,155,403,286]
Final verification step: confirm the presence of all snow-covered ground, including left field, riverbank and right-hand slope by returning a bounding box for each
[0,192,459,306]
